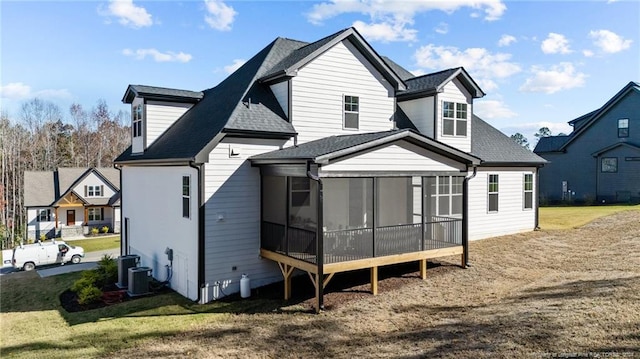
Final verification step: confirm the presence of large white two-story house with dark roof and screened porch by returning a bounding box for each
[115,28,545,307]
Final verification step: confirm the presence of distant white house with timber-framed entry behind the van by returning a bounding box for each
[24,168,120,240]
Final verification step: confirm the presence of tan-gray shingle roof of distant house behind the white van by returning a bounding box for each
[24,167,120,207]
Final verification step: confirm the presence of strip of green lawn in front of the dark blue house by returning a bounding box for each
[540,205,640,230]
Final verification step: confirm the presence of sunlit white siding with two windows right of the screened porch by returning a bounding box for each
[469,167,537,240]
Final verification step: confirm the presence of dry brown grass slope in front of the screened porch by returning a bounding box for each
[109,211,640,358]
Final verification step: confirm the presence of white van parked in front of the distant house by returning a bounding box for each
[12,241,84,271]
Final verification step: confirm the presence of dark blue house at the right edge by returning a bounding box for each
[534,82,640,203]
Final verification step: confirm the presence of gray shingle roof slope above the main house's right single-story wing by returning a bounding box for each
[471,115,547,166]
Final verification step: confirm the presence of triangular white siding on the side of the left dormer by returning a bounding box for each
[144,101,193,147]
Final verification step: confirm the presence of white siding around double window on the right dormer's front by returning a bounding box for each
[432,79,473,152]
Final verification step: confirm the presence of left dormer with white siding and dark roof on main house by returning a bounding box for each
[122,85,203,153]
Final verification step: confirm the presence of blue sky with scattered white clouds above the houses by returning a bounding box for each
[0,0,640,141]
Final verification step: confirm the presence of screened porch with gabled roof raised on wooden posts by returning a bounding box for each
[252,130,477,309]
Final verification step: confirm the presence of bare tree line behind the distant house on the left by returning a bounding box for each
[0,98,131,249]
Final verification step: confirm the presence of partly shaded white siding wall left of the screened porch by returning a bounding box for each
[204,139,282,299]
